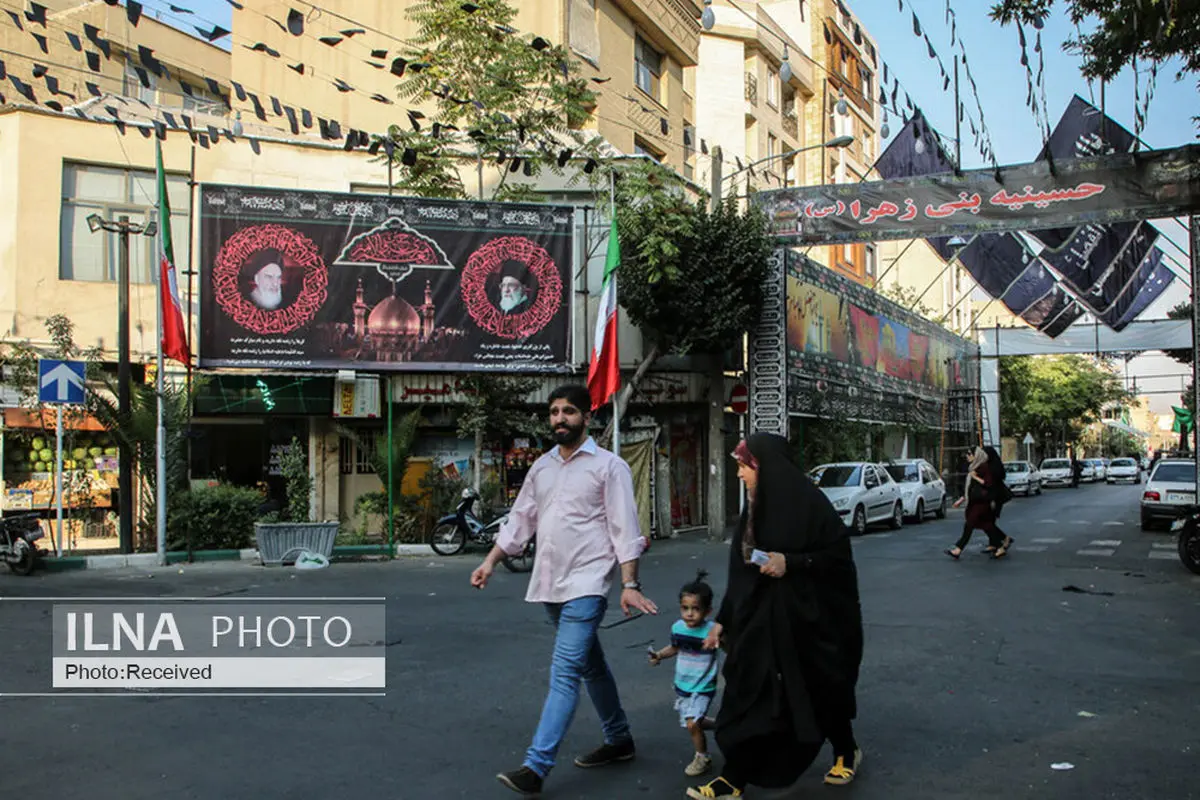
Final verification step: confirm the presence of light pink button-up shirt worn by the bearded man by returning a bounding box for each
[496,437,646,603]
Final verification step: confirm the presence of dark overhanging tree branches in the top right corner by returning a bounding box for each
[991,0,1200,124]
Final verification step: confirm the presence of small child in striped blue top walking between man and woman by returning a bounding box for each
[649,570,720,776]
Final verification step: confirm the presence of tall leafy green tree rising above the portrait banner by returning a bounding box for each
[383,0,599,200]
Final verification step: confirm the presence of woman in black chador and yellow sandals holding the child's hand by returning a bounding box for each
[688,433,863,799]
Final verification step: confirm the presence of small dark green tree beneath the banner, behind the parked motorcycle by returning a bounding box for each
[458,374,545,492]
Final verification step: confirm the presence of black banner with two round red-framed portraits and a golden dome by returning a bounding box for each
[199,184,575,372]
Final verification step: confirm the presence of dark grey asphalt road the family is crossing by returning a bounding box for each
[0,485,1200,800]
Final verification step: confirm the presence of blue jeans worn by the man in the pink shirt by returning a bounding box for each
[524,596,631,777]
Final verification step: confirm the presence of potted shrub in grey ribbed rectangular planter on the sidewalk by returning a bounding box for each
[254,437,338,565]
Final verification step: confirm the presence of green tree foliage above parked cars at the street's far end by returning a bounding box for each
[1000,355,1132,444]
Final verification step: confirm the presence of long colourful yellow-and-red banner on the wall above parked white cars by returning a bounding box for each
[787,252,974,419]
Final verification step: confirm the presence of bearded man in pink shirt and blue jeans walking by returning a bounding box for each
[470,385,658,795]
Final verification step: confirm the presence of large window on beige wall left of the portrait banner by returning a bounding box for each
[59,163,192,283]
